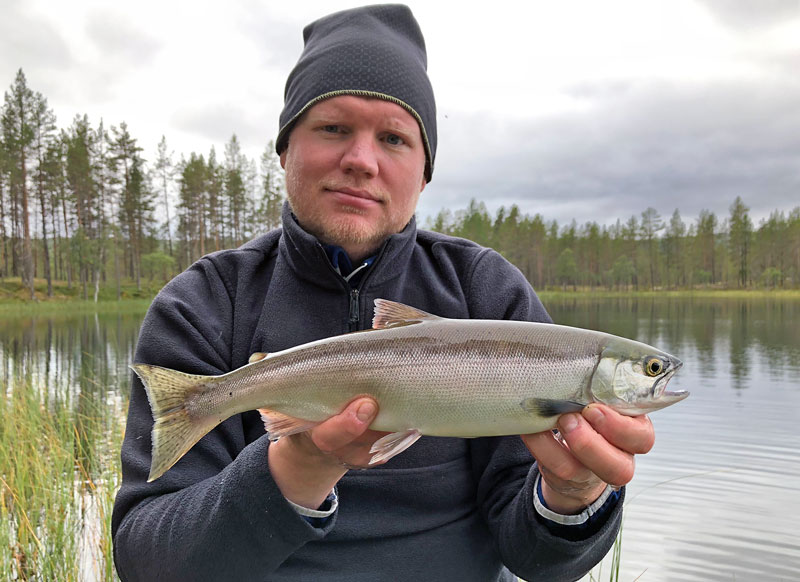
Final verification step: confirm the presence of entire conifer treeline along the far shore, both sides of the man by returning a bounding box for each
[0,70,800,299]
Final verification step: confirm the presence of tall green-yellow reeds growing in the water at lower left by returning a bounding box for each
[0,379,124,582]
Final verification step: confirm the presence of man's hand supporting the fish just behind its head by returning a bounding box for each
[522,404,655,515]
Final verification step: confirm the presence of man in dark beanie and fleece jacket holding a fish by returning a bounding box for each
[113,5,654,582]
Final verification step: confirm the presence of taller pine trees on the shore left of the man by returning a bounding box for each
[0,69,284,299]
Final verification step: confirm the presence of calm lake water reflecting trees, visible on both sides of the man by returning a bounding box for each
[0,300,800,582]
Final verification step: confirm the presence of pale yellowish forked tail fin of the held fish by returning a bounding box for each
[131,364,219,483]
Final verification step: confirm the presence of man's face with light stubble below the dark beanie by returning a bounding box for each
[281,95,426,261]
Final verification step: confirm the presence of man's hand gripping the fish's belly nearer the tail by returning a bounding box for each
[268,398,387,509]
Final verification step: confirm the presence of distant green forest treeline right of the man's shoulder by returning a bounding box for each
[427,196,800,290]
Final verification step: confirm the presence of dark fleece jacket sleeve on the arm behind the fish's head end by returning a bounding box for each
[460,250,622,582]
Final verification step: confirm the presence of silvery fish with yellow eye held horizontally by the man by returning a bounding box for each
[131,299,689,482]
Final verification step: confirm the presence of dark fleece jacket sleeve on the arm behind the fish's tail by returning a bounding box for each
[112,259,336,582]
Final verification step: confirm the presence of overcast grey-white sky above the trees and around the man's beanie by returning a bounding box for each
[0,0,800,232]
